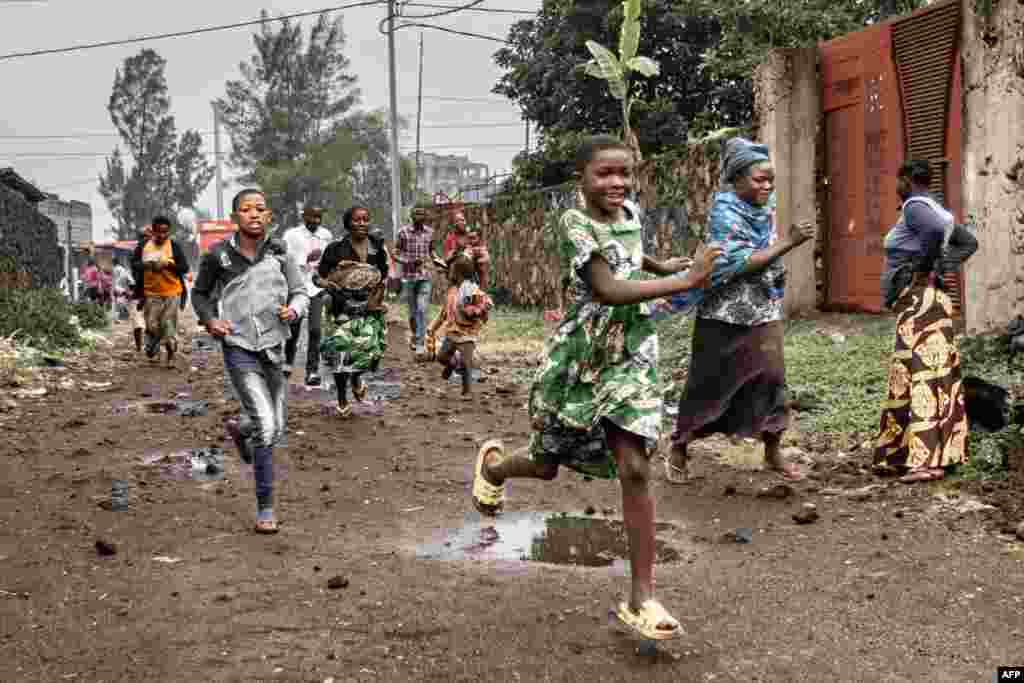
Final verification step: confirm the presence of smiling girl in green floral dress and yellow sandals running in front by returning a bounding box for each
[473,135,721,640]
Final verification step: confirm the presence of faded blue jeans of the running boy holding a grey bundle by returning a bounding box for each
[224,344,288,508]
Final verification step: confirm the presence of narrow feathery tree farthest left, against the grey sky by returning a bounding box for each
[99,49,214,239]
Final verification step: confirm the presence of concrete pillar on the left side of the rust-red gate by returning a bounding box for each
[754,47,823,313]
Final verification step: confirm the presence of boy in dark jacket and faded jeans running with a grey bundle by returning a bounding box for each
[193,189,309,533]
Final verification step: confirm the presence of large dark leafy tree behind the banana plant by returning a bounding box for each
[493,0,729,185]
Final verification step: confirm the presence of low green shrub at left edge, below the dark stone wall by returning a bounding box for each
[0,288,82,349]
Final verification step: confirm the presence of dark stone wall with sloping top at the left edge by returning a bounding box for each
[0,185,63,287]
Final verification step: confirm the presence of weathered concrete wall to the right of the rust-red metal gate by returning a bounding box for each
[962,0,1024,333]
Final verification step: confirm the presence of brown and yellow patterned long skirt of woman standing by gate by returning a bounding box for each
[874,282,968,472]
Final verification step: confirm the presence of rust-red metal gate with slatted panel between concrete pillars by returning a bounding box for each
[820,0,963,312]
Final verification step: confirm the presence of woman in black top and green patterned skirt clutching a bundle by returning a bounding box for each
[316,207,389,418]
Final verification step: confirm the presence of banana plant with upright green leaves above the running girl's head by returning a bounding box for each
[584,0,660,163]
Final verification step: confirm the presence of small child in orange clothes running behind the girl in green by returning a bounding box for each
[427,254,494,396]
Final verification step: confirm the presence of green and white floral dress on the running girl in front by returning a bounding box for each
[529,203,662,479]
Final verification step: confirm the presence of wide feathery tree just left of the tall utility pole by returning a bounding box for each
[217,11,359,225]
